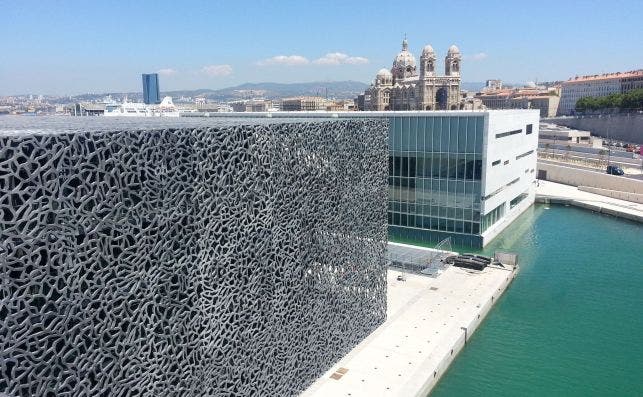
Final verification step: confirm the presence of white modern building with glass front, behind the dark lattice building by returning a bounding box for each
[210,110,540,248]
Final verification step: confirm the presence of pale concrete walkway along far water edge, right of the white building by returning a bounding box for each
[536,181,643,223]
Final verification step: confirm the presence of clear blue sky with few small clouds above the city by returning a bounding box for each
[0,0,643,95]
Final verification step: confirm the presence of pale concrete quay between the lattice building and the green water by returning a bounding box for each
[302,266,517,397]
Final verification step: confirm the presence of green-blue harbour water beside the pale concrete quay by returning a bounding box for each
[431,205,643,397]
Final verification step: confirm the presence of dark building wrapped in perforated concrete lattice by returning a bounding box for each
[0,117,388,396]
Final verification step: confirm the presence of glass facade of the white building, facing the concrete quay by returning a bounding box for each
[388,115,484,246]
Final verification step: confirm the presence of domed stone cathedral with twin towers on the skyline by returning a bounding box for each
[364,38,463,111]
